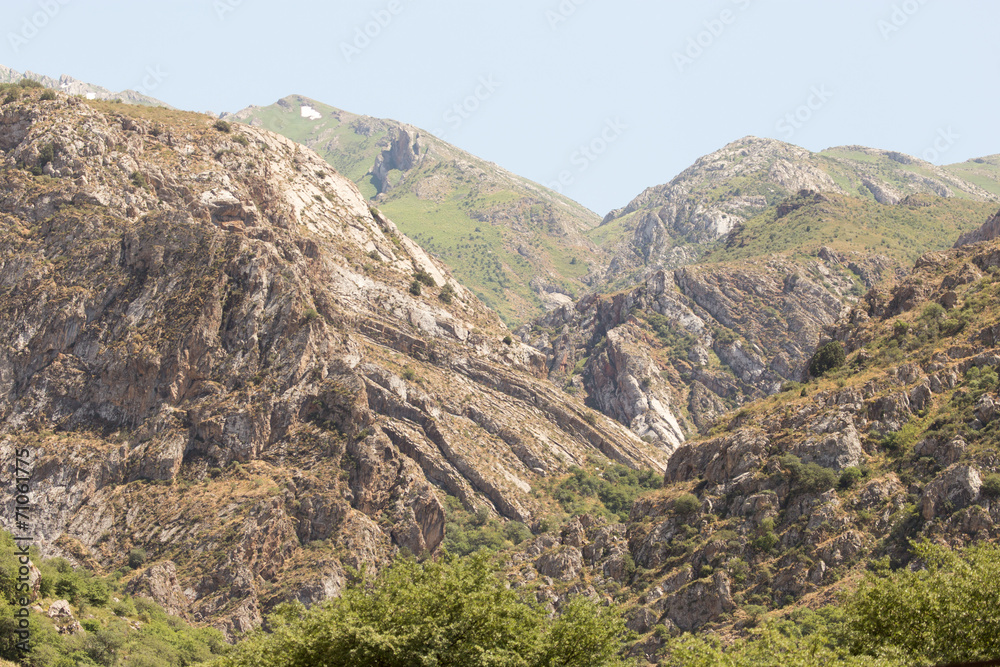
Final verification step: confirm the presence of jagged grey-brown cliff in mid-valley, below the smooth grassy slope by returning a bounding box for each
[519,248,892,449]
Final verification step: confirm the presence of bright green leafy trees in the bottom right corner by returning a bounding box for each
[660,542,1000,667]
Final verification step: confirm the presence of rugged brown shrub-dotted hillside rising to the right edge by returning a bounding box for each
[515,218,1000,664]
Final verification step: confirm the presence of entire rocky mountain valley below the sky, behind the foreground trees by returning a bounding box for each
[0,75,1000,665]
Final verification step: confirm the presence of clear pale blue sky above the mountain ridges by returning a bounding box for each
[0,0,1000,215]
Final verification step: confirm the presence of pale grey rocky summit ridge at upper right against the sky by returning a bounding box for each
[591,137,1000,285]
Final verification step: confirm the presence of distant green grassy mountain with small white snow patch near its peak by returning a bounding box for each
[223,95,604,323]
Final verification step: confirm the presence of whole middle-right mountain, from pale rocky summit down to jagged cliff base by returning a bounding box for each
[518,137,997,462]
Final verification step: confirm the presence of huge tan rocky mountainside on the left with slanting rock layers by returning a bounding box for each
[0,93,669,633]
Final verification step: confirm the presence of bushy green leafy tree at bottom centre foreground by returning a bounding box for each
[216,554,628,667]
